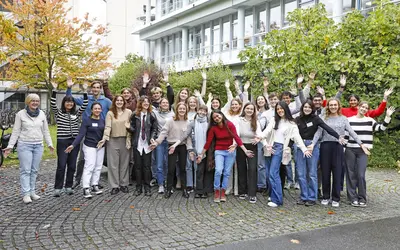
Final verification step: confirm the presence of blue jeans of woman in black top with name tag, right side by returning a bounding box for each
[296,140,319,201]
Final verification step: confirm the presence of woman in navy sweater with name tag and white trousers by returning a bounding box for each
[65,102,105,199]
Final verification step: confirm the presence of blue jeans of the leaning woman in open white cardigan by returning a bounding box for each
[269,142,283,205]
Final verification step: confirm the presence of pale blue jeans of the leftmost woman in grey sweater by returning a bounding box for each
[17,142,43,196]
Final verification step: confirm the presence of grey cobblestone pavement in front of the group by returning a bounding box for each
[0,160,400,249]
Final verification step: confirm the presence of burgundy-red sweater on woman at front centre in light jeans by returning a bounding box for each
[204,121,243,150]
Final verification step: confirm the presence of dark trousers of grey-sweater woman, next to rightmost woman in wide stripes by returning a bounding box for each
[320,142,344,201]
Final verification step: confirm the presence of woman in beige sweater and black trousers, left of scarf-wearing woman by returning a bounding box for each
[151,102,192,198]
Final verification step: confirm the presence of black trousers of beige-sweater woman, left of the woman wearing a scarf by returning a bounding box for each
[167,145,187,190]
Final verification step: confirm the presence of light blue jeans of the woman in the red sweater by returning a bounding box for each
[214,150,236,191]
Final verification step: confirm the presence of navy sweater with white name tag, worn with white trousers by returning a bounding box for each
[72,117,105,148]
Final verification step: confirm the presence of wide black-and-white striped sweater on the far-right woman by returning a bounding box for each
[346,116,390,149]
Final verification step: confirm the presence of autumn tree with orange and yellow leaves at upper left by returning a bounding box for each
[0,0,111,91]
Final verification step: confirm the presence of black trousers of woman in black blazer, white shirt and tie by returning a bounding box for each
[133,148,152,191]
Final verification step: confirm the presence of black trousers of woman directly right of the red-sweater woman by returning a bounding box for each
[236,143,258,197]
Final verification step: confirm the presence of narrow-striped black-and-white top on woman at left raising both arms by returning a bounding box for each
[50,90,88,139]
